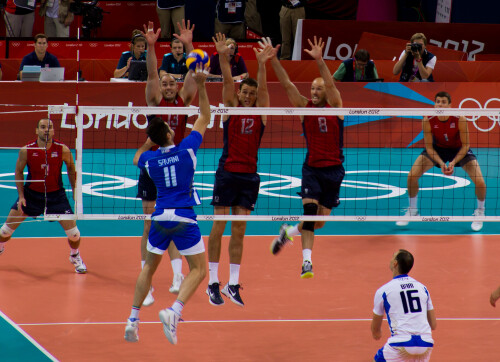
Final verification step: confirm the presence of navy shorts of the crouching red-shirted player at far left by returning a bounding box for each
[11,186,73,217]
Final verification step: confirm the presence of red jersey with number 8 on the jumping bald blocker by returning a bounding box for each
[302,100,344,167]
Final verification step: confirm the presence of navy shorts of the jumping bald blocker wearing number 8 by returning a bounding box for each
[299,164,345,209]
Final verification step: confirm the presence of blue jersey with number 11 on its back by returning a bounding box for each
[137,131,203,209]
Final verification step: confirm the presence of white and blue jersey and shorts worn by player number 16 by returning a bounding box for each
[373,274,434,362]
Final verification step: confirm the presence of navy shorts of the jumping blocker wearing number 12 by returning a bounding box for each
[211,169,260,211]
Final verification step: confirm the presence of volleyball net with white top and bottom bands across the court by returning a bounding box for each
[0,105,500,221]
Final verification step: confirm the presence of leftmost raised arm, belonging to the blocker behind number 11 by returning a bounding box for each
[141,21,162,106]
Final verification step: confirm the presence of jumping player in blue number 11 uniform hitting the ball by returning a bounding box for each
[125,62,210,344]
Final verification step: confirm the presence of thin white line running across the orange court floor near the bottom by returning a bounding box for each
[19,318,500,326]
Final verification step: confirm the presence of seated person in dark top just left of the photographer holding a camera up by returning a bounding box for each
[333,49,378,82]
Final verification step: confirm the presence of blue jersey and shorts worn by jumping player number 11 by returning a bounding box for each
[138,131,205,255]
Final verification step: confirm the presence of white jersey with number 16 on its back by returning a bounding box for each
[373,275,434,343]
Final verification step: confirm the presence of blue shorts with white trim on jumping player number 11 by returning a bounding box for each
[147,208,205,255]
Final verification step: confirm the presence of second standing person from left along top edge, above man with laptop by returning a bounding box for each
[38,0,75,38]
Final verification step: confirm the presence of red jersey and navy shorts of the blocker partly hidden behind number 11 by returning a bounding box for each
[137,94,187,201]
